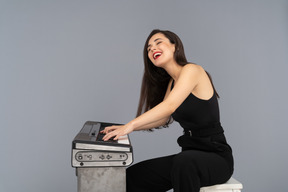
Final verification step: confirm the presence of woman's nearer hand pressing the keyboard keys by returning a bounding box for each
[103,123,133,141]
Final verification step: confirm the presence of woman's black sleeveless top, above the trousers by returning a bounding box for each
[171,81,233,169]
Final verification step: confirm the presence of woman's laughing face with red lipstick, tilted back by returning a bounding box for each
[147,33,175,67]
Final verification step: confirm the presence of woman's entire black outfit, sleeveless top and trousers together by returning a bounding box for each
[126,81,233,192]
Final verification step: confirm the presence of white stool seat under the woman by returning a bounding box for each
[200,177,243,192]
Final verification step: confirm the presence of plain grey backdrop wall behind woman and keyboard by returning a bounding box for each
[0,0,288,192]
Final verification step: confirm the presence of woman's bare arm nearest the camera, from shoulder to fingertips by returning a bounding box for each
[103,64,205,140]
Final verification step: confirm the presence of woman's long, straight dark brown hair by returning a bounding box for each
[136,29,218,125]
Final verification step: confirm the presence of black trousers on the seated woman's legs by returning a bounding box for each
[126,150,233,192]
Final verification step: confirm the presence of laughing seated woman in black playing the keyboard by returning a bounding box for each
[104,30,233,192]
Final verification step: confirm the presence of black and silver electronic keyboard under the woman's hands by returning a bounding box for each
[72,121,133,167]
